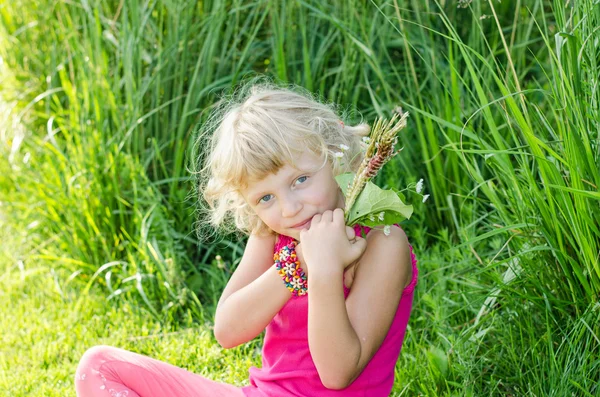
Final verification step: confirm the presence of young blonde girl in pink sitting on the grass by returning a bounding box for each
[75,84,417,397]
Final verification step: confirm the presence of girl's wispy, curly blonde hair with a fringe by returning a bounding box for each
[195,82,370,234]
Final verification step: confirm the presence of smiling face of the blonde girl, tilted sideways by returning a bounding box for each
[242,151,344,240]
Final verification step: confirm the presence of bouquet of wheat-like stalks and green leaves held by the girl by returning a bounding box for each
[336,112,413,235]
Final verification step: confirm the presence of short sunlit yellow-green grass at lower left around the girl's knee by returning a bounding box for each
[0,230,260,397]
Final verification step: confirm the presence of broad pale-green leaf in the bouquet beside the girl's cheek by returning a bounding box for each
[335,173,413,227]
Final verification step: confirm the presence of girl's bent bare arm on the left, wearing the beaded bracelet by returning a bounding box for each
[214,235,292,349]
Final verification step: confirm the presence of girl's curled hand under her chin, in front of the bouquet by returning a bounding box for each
[300,208,367,274]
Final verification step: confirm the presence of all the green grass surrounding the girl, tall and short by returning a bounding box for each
[0,0,600,396]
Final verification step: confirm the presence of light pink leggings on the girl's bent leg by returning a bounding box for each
[75,346,262,397]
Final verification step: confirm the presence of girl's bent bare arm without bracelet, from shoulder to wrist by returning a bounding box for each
[305,227,412,389]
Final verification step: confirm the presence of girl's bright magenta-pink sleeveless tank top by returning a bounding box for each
[242,225,418,397]
